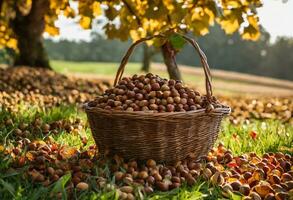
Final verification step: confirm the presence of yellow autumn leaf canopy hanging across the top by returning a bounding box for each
[0,0,262,47]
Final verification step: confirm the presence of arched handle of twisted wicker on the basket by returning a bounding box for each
[114,33,213,102]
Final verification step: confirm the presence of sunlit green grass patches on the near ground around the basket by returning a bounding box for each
[0,104,293,200]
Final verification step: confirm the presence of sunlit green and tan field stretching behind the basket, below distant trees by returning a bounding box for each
[51,60,293,96]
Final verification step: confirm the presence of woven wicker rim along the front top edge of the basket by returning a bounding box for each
[83,102,231,117]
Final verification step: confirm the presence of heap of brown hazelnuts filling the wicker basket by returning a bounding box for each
[88,73,222,112]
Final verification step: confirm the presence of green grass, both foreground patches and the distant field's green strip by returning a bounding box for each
[0,61,293,200]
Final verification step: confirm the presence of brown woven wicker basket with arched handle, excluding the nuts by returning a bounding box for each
[85,35,230,163]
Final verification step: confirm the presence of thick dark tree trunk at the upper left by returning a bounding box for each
[12,0,51,69]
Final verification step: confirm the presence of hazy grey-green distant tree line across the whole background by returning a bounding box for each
[0,26,293,80]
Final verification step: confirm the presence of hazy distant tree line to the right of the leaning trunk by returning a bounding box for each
[177,26,293,80]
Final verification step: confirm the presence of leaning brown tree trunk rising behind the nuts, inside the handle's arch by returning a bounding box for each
[162,42,182,80]
